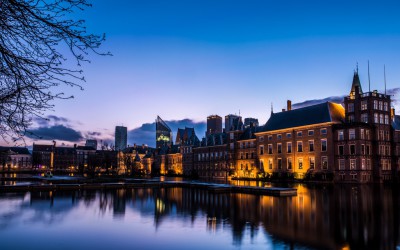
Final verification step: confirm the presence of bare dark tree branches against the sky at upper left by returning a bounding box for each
[0,0,110,139]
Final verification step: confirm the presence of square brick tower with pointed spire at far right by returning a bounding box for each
[344,71,392,182]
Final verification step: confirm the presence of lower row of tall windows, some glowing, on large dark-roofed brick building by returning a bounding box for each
[260,156,328,170]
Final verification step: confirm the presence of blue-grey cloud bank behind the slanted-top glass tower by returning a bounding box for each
[128,119,206,147]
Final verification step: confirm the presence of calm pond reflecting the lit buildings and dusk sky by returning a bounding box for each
[0,185,400,250]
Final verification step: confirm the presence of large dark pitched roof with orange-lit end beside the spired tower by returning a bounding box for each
[262,102,344,131]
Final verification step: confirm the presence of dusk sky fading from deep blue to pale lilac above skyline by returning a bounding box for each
[4,0,400,146]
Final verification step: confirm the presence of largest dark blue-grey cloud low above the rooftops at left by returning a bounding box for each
[26,125,83,142]
